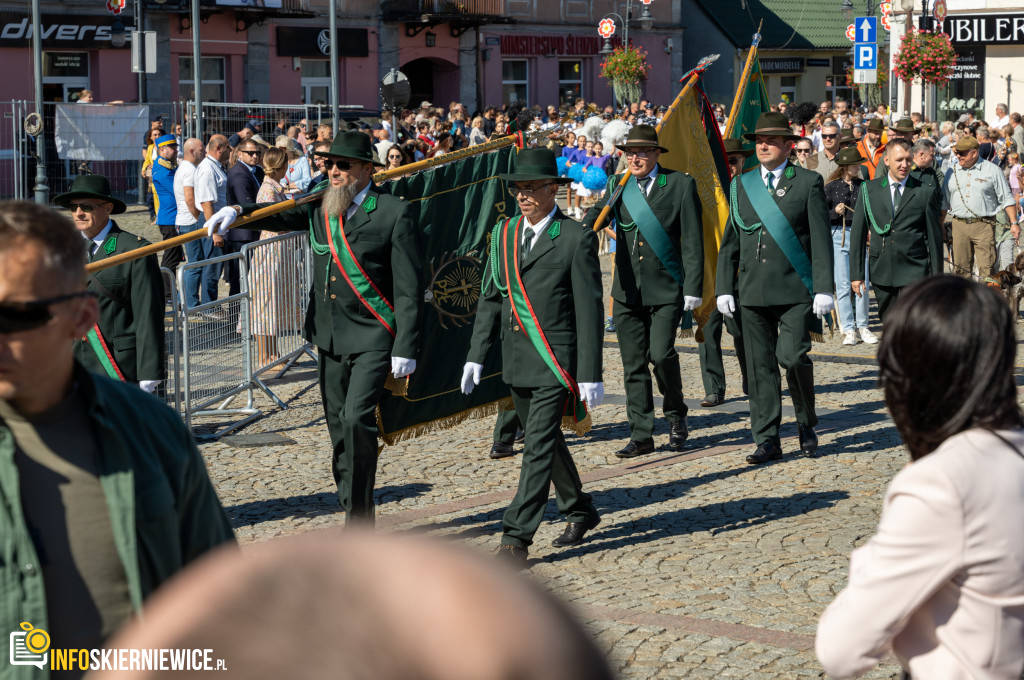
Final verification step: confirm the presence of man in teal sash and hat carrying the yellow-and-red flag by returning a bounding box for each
[584,125,703,458]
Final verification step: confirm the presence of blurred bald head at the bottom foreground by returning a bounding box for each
[92,529,612,680]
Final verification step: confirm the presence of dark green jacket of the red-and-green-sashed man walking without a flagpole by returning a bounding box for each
[466,210,604,387]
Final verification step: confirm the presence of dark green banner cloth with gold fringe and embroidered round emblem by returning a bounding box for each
[377,148,516,444]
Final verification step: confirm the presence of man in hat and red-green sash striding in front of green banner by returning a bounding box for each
[462,148,604,566]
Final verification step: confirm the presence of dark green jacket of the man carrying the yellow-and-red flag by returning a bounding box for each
[584,166,703,305]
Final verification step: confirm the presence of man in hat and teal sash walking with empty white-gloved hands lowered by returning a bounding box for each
[716,113,834,465]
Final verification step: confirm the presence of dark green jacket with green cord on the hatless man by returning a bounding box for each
[850,172,942,286]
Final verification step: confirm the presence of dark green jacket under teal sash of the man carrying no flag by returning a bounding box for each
[716,164,835,307]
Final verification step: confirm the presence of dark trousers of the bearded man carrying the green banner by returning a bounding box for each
[319,349,391,522]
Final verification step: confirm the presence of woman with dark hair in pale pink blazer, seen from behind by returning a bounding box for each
[816,274,1024,680]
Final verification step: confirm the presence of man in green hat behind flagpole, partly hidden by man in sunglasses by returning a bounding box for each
[53,175,167,392]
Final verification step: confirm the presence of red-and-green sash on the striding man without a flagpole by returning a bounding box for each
[502,215,591,434]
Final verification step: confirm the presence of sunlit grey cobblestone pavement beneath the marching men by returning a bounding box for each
[114,200,908,678]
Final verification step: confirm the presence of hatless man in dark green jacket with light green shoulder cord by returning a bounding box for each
[850,138,942,322]
